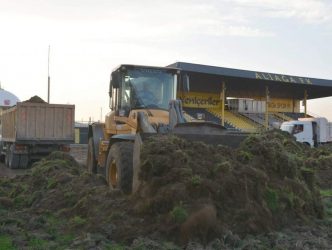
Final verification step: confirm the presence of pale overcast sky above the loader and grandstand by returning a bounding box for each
[0,0,332,121]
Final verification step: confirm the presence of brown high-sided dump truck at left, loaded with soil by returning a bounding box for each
[0,102,75,168]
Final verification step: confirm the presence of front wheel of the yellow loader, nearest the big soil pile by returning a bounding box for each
[105,142,133,194]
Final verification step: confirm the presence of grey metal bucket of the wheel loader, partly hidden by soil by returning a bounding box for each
[133,122,248,193]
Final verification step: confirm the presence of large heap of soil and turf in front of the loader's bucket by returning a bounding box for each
[132,131,324,241]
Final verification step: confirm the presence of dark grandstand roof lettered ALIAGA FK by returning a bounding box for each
[168,62,332,100]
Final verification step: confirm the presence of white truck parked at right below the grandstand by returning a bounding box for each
[280,117,332,147]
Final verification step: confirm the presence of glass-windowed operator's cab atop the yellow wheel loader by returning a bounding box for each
[109,65,180,116]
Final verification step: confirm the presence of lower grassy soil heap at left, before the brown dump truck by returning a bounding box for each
[0,152,121,249]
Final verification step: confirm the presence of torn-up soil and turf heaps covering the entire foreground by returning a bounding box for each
[0,131,332,249]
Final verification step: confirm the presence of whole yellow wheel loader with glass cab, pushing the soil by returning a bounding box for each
[86,65,246,194]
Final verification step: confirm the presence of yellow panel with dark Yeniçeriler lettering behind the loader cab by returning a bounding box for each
[178,92,221,109]
